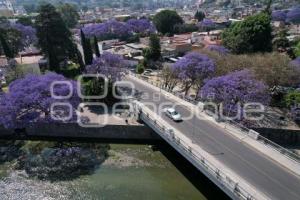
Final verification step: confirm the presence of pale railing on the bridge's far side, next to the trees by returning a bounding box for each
[130,73,300,163]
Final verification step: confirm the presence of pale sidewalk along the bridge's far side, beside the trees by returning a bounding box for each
[129,75,300,177]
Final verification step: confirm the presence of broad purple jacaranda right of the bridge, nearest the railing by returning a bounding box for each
[198,70,270,118]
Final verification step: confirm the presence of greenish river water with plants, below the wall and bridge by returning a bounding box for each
[0,141,227,200]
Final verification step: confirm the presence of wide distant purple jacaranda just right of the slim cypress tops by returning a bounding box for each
[82,20,132,40]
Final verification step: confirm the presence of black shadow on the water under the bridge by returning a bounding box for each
[154,141,230,200]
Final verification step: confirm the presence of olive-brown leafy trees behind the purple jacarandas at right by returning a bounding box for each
[201,50,300,87]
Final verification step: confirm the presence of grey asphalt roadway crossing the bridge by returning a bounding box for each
[128,78,300,200]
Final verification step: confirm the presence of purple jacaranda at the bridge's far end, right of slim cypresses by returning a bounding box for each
[86,52,127,82]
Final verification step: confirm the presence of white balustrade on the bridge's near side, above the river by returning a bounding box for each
[137,103,255,200]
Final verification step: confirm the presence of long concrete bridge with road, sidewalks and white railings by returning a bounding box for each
[122,75,300,200]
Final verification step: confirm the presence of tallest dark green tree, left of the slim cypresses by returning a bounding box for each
[35,4,76,72]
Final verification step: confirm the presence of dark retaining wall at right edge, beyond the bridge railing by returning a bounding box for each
[252,128,300,145]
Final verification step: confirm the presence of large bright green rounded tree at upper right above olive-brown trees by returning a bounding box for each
[222,12,272,54]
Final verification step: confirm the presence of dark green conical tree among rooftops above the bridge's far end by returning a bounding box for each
[143,34,161,61]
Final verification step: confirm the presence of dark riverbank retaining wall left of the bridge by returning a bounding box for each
[0,123,159,140]
